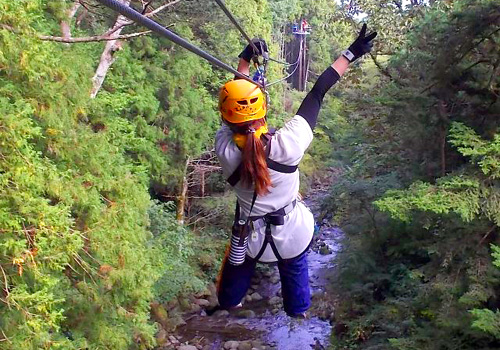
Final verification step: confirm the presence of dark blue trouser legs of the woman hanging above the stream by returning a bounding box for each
[217,253,311,316]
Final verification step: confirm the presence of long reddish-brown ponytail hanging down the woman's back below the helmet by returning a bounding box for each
[229,119,272,196]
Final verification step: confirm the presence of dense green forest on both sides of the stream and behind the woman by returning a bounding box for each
[0,0,500,350]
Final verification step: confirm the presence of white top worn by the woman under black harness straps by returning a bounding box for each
[215,115,314,262]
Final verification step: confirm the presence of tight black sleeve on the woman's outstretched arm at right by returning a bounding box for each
[297,66,340,129]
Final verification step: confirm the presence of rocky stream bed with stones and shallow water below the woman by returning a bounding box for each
[152,191,342,350]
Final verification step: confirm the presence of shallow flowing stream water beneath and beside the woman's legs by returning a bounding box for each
[173,194,342,350]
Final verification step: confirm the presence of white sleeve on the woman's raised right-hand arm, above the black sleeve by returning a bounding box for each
[269,115,313,165]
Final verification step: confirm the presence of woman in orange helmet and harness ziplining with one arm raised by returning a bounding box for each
[215,24,377,317]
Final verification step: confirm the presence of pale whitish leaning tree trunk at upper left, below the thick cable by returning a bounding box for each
[90,0,130,98]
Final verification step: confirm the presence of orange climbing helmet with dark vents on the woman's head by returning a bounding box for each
[219,79,267,124]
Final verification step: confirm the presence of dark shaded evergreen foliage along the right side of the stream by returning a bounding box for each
[324,0,500,350]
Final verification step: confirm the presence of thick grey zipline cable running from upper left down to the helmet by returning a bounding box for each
[97,0,262,88]
